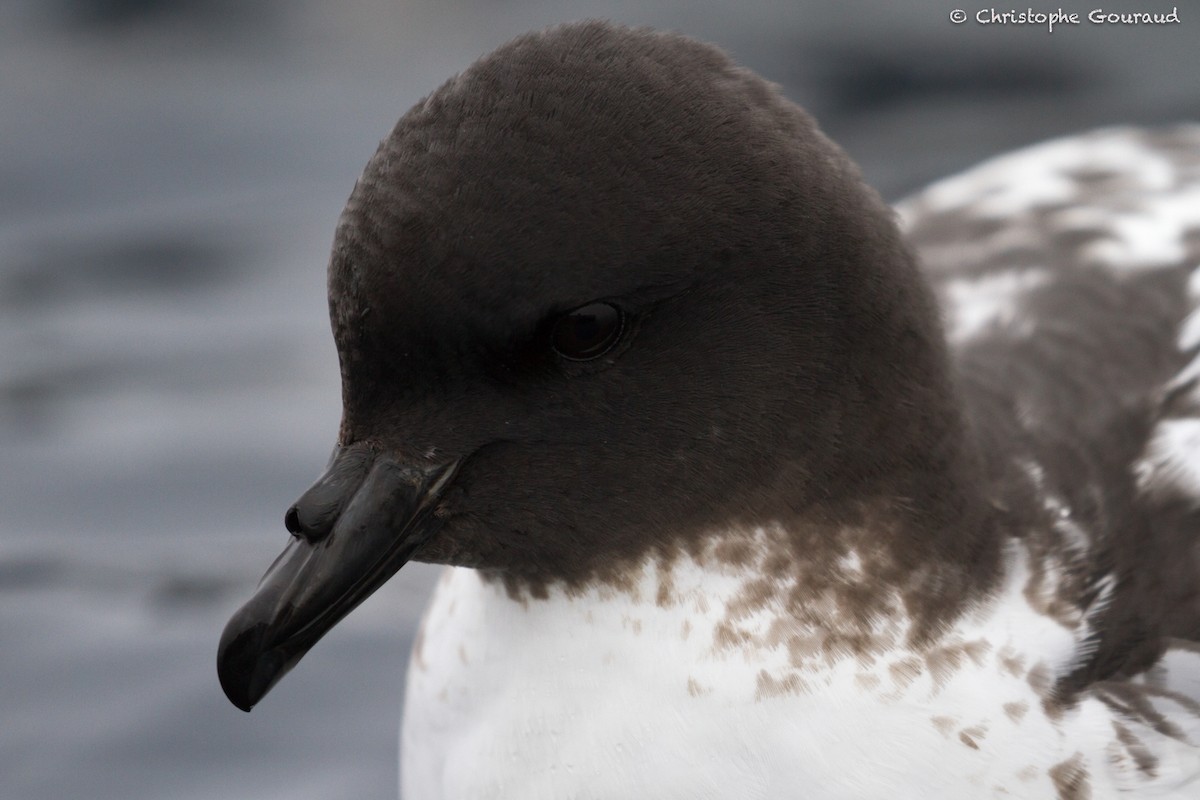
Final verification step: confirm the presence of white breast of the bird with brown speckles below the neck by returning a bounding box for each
[401,532,1184,800]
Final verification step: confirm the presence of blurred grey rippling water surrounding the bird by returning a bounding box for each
[0,0,1200,800]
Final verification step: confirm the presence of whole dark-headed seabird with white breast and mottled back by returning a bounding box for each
[218,22,1200,800]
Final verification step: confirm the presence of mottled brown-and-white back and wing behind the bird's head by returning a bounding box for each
[898,125,1200,688]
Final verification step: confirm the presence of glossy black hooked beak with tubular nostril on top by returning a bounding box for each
[217,444,460,711]
